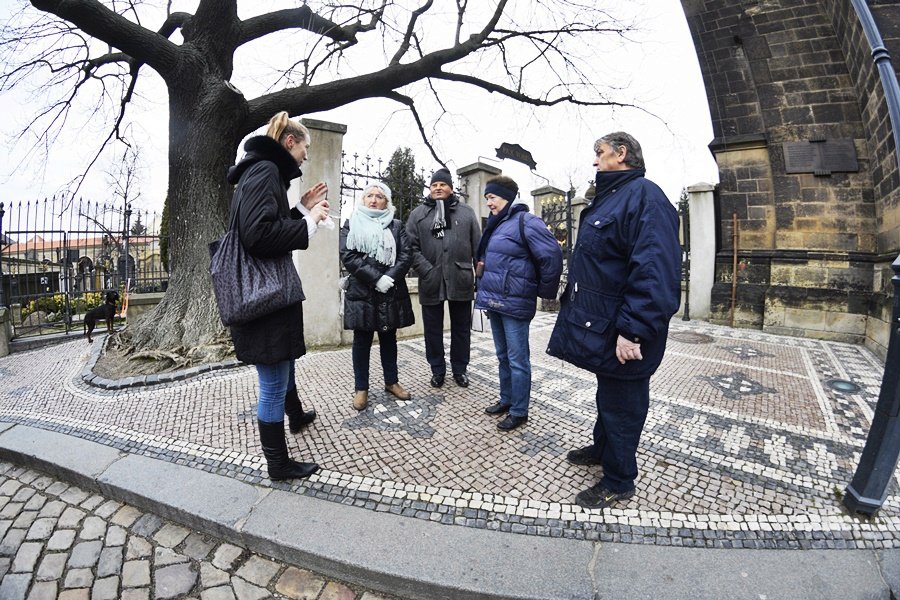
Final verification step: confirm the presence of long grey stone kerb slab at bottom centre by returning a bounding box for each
[242,491,594,600]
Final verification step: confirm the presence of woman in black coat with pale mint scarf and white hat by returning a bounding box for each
[341,182,415,410]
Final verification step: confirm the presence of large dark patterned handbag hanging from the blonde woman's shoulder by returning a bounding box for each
[209,179,304,326]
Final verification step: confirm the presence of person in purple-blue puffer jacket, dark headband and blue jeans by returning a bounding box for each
[475,175,562,431]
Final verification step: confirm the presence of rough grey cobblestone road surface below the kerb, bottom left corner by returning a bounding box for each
[0,462,404,600]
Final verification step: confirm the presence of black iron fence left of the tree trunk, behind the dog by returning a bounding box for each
[0,198,169,336]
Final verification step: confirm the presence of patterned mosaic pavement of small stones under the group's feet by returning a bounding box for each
[0,314,900,549]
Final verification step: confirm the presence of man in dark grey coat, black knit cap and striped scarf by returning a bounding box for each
[406,169,481,387]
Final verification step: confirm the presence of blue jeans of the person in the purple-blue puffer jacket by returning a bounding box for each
[488,311,531,417]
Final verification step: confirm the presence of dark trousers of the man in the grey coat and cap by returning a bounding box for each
[422,300,472,375]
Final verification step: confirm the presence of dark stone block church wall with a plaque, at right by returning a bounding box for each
[682,0,900,353]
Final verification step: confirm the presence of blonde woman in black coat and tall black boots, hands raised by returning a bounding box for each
[228,112,328,480]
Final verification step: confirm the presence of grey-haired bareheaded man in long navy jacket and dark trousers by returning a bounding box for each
[547,132,681,508]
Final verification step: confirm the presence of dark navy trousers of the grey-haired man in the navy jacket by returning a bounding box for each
[594,375,650,492]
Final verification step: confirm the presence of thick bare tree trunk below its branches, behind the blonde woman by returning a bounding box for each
[121,78,246,368]
